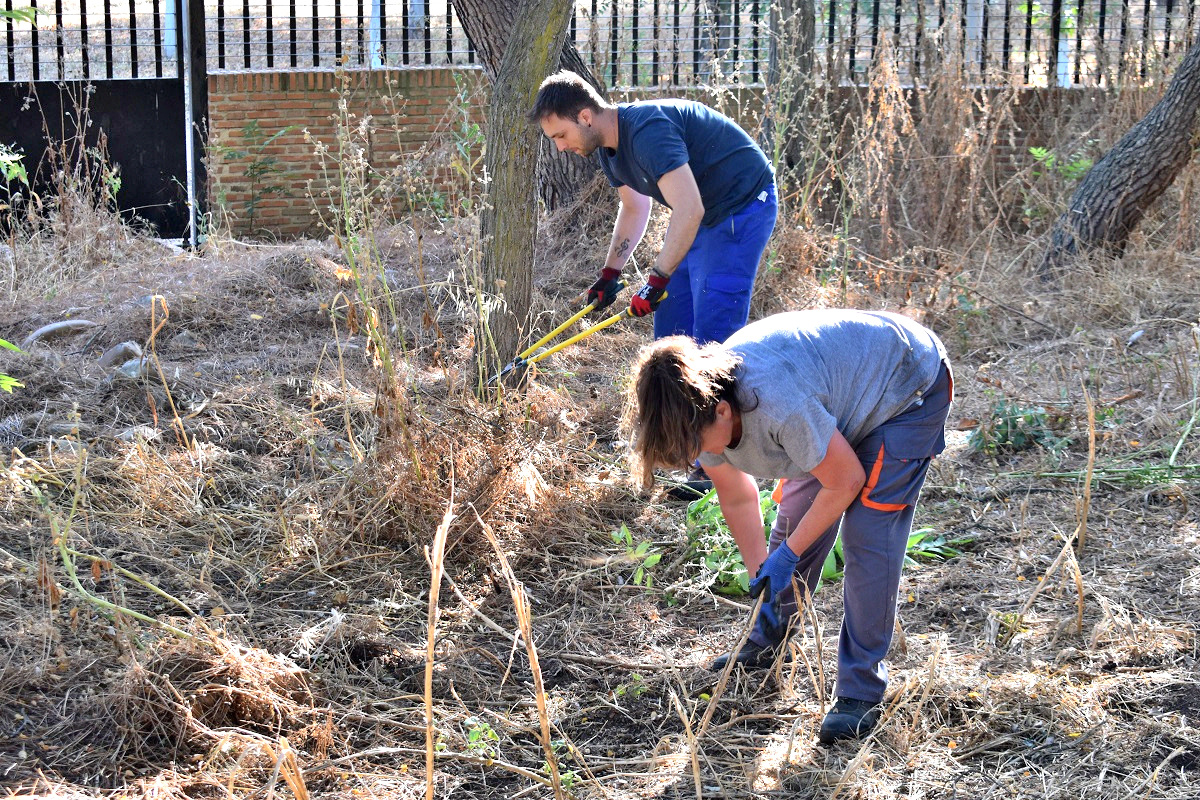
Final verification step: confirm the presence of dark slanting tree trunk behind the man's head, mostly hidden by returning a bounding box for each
[452,0,607,211]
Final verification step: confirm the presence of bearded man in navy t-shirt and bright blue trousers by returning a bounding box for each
[529,71,776,343]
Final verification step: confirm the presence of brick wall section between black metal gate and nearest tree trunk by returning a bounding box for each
[208,68,484,237]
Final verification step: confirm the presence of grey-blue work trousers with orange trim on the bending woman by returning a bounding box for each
[750,363,954,702]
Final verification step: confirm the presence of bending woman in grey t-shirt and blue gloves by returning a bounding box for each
[628,309,953,744]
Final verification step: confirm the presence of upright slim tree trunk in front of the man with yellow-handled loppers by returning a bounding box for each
[475,0,575,383]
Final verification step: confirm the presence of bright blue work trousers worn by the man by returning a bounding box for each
[654,184,779,344]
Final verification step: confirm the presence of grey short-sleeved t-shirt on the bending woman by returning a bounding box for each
[700,309,946,479]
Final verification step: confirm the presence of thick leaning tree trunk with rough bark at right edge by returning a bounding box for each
[1038,43,1200,277]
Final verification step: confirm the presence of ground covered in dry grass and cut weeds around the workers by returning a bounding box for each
[0,209,1200,800]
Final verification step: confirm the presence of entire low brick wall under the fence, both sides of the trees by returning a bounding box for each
[209,68,1108,237]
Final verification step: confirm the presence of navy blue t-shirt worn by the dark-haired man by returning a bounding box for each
[598,100,774,225]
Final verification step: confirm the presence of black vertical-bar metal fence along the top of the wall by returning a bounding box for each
[0,0,1200,86]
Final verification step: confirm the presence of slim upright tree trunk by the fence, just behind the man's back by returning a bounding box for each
[761,0,817,169]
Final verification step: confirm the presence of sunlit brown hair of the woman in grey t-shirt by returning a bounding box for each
[623,336,742,486]
